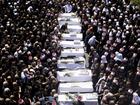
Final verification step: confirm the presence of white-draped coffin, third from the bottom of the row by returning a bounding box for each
[57,69,92,82]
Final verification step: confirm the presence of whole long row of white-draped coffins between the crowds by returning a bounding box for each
[57,13,98,105]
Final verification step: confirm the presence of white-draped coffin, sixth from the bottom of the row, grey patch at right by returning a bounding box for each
[60,40,84,48]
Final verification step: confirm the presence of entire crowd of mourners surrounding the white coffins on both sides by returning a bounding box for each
[0,0,140,105]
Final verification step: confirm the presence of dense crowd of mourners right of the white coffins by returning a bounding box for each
[66,0,140,105]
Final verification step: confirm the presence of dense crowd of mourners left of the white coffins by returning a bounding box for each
[0,0,64,105]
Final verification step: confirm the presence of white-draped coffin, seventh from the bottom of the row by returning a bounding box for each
[62,33,83,40]
